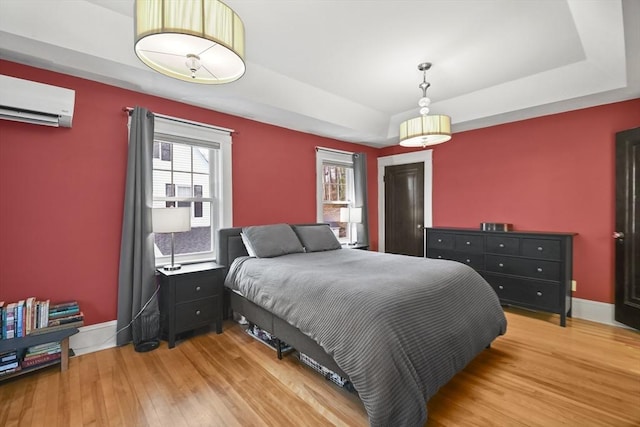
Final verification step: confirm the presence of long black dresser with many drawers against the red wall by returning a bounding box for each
[426,228,575,326]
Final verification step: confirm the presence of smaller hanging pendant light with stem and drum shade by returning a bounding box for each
[400,62,451,148]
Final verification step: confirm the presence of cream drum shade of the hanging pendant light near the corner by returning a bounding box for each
[400,115,451,147]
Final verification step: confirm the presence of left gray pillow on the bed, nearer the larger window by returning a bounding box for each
[242,224,304,258]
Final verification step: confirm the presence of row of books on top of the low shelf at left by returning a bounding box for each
[0,297,84,339]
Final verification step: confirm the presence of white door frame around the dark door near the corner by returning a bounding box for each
[378,150,433,252]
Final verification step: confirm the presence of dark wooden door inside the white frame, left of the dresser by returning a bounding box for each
[384,163,424,256]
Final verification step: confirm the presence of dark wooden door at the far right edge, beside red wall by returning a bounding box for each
[613,128,640,329]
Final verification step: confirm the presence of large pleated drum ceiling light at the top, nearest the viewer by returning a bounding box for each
[134,0,245,84]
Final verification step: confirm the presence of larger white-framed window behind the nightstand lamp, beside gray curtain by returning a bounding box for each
[146,116,231,265]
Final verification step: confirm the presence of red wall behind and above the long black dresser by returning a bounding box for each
[381,99,640,303]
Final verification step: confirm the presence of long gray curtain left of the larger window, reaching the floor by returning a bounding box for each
[116,107,160,345]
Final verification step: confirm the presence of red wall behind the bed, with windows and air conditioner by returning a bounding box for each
[0,61,378,325]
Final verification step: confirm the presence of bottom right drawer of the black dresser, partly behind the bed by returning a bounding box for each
[483,273,560,313]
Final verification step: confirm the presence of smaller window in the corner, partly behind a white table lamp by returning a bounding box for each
[316,149,357,243]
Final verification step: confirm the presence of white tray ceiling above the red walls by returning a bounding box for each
[0,0,640,147]
